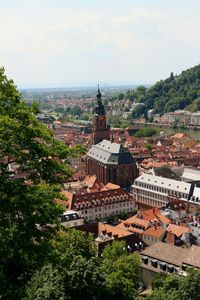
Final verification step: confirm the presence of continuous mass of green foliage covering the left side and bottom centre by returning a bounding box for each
[0,69,139,300]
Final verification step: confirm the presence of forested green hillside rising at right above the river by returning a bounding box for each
[133,64,200,117]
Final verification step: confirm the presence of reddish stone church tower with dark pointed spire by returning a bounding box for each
[93,85,110,144]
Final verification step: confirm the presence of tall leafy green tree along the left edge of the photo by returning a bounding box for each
[0,68,76,299]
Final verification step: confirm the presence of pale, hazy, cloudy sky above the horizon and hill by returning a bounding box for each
[0,0,200,88]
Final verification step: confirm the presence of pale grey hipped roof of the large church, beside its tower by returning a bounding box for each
[87,140,134,165]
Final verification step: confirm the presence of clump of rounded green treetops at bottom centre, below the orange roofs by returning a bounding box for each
[25,239,139,300]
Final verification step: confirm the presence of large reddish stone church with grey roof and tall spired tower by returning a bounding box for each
[86,87,138,188]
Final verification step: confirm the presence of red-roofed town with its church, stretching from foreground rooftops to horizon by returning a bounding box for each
[15,87,200,291]
